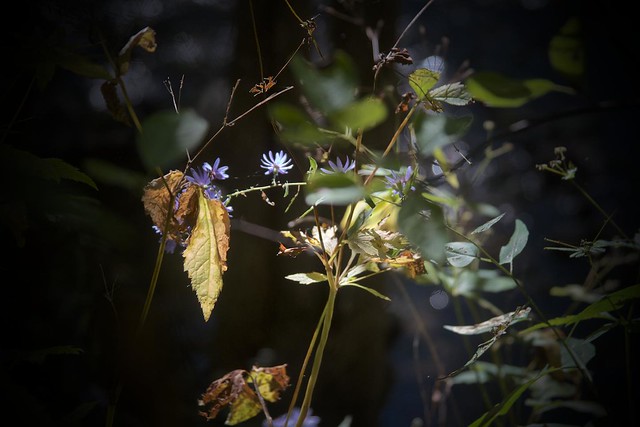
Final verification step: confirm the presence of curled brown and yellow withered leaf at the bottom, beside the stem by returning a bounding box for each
[198,364,289,425]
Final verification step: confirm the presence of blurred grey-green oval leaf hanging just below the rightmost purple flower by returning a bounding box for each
[397,192,449,263]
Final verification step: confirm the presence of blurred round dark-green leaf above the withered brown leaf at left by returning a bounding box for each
[136,110,209,171]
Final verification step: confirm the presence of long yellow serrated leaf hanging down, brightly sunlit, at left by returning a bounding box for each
[183,192,230,321]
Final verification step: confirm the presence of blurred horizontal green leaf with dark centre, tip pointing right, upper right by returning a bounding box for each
[466,71,565,108]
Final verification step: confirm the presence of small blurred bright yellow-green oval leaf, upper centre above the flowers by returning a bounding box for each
[329,97,387,132]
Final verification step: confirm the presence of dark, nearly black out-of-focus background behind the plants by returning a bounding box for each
[0,0,640,427]
